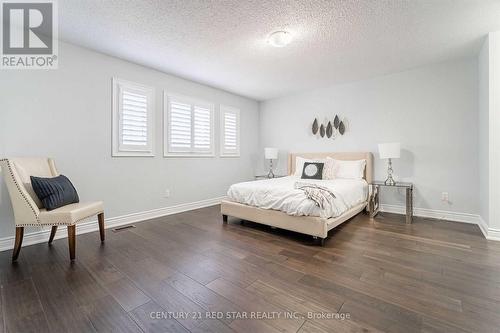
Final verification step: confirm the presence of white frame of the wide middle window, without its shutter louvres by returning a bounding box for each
[163,90,215,158]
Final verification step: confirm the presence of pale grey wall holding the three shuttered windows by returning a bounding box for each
[0,43,259,237]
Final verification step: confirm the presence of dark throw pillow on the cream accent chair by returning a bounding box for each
[30,175,80,210]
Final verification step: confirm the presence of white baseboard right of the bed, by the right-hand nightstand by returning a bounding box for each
[380,204,500,241]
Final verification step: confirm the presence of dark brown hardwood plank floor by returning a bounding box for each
[0,206,500,333]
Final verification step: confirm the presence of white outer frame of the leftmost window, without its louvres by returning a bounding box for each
[111,77,156,157]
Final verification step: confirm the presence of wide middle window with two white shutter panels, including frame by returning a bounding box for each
[164,94,214,157]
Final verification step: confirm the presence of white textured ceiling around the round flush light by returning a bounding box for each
[59,0,500,100]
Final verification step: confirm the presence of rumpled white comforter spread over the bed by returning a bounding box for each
[227,176,368,218]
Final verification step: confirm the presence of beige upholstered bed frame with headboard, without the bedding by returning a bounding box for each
[221,152,373,245]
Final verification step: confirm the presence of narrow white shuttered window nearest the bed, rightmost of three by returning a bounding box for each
[220,105,240,157]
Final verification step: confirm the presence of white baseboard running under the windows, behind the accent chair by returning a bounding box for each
[0,197,225,251]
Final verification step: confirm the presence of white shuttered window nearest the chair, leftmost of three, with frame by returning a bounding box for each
[112,78,154,156]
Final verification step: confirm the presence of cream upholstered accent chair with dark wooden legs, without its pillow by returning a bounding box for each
[0,158,104,261]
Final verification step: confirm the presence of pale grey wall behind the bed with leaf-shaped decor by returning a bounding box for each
[260,59,479,214]
